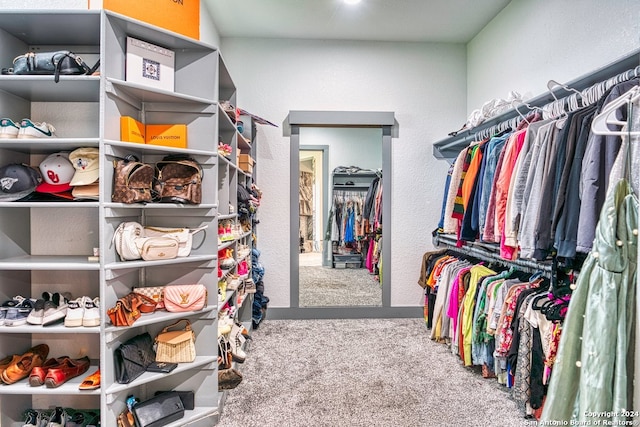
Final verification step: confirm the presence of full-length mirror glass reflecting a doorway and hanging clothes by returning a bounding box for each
[298,127,384,307]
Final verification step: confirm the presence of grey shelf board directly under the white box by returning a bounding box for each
[106,78,218,114]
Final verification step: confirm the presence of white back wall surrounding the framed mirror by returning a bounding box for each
[221,38,466,307]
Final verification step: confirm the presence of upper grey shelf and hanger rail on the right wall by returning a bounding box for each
[433,49,640,163]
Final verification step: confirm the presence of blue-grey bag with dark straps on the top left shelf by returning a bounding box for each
[12,50,100,83]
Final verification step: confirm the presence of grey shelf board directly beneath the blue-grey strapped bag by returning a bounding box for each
[0,76,100,103]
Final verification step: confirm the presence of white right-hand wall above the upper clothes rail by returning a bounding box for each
[467,0,640,112]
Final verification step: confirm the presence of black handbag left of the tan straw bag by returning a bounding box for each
[113,332,156,384]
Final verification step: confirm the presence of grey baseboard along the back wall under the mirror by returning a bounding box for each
[264,307,424,320]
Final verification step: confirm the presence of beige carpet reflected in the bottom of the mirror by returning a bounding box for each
[299,265,382,307]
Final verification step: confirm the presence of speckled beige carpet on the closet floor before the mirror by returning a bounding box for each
[218,319,528,427]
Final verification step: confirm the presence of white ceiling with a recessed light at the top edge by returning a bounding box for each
[203,0,510,43]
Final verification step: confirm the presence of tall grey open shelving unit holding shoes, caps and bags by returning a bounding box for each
[0,10,222,427]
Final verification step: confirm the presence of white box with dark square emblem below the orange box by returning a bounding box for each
[125,37,175,92]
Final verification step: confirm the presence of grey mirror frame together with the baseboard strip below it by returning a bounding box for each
[280,111,421,319]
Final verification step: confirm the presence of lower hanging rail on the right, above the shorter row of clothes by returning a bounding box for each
[433,234,553,279]
